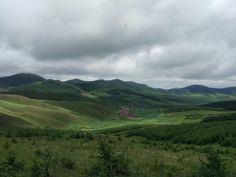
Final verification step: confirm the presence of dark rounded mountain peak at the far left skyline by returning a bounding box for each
[0,73,45,88]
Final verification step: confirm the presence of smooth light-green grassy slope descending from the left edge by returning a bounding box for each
[0,95,91,129]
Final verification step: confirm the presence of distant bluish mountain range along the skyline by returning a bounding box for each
[0,73,236,94]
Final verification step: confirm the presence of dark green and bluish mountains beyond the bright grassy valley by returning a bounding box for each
[0,73,236,108]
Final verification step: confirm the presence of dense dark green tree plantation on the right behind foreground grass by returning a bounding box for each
[126,121,236,147]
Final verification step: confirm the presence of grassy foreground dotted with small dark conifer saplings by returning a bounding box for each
[0,127,236,177]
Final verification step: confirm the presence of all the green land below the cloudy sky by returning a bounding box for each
[0,74,236,177]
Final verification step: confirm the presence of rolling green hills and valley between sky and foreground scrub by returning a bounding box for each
[0,74,236,129]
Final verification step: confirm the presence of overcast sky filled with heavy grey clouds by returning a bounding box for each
[0,0,236,88]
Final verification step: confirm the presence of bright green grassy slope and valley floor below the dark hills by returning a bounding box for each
[0,95,235,129]
